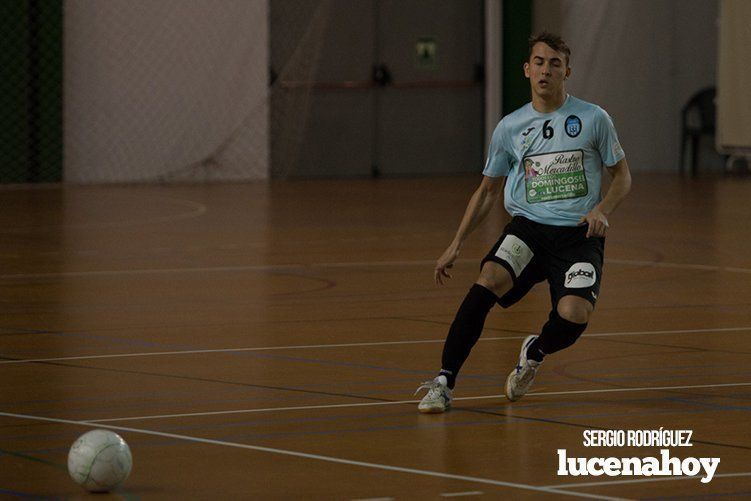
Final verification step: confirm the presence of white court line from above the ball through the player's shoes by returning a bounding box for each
[87,382,751,423]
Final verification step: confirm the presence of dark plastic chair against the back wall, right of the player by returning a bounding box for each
[680,87,717,176]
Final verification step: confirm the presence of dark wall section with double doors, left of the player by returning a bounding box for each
[270,0,485,177]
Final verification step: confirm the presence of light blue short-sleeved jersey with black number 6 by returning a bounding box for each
[483,96,625,226]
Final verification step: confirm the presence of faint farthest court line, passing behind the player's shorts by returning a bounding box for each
[0,258,751,279]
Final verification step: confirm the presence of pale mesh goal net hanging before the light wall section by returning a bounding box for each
[64,0,331,183]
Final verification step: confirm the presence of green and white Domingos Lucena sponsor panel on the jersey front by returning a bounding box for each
[522,150,589,204]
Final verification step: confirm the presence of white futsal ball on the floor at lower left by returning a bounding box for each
[68,430,133,492]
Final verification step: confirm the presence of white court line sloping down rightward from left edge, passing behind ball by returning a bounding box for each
[0,412,623,500]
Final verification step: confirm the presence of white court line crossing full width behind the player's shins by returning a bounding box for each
[0,327,751,365]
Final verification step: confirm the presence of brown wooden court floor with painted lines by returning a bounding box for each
[0,174,751,500]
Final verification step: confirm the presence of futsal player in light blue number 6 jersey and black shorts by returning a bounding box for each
[418,32,631,413]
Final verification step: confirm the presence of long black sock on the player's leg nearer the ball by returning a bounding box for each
[440,284,498,389]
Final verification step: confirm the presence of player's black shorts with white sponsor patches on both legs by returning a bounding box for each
[482,216,605,308]
